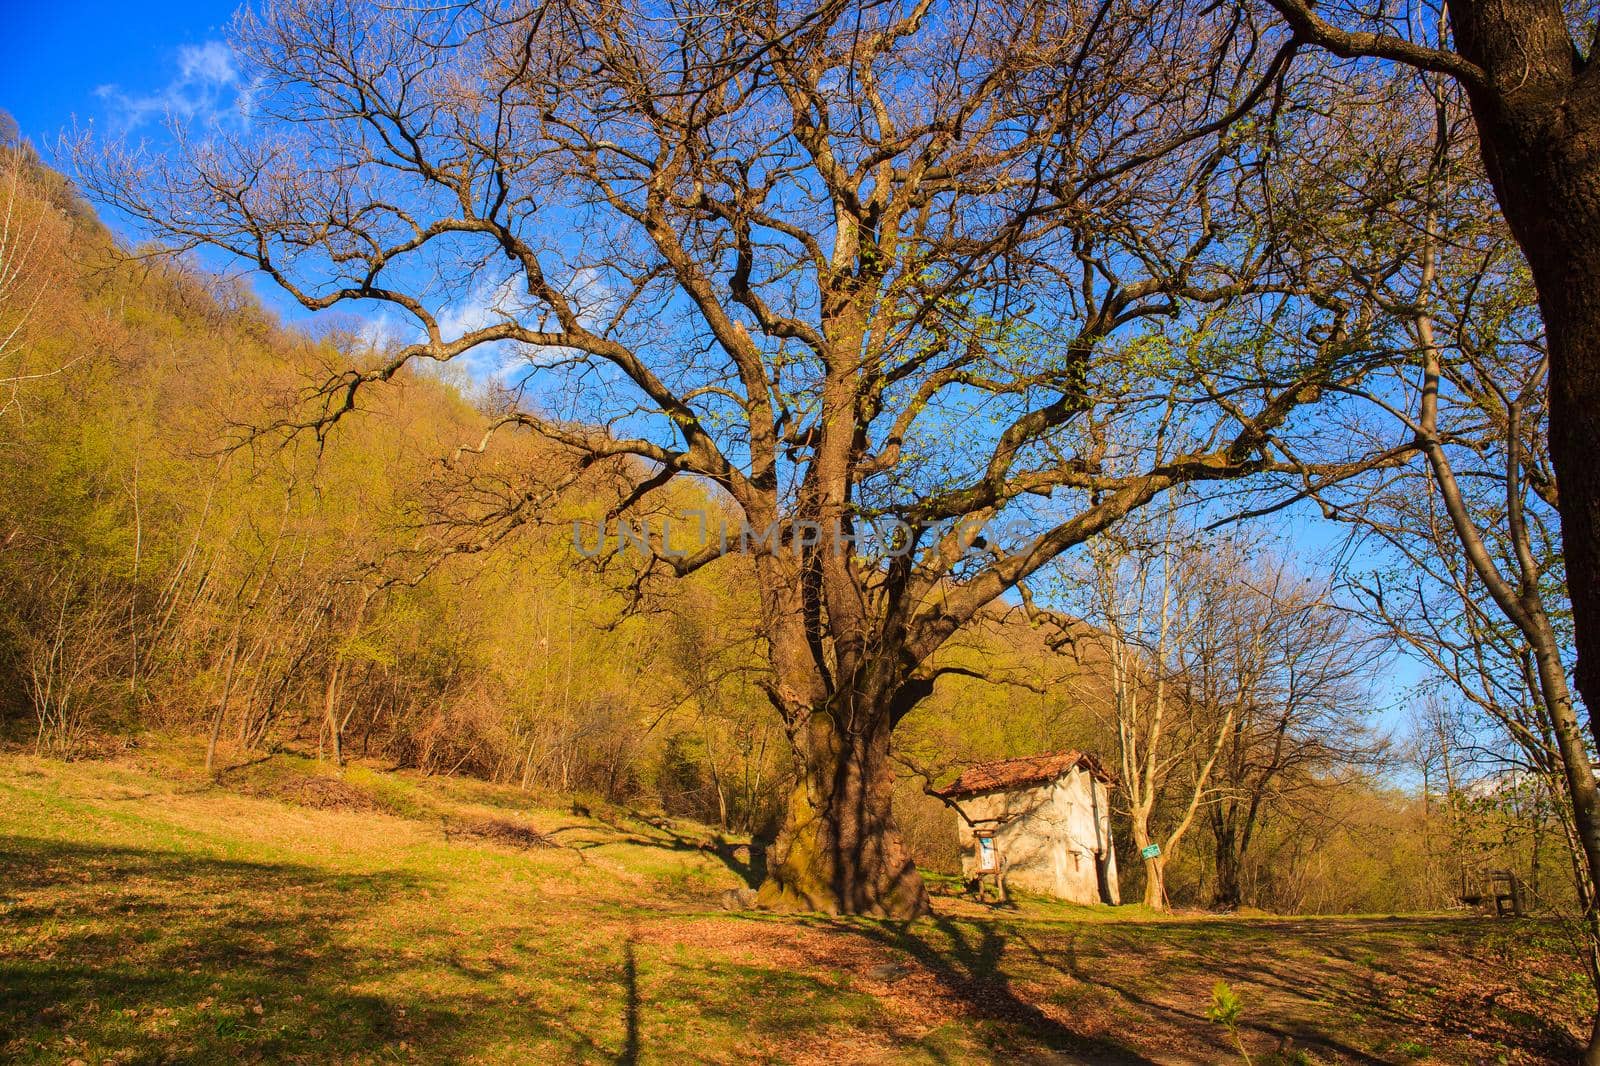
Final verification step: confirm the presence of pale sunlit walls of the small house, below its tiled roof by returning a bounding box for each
[957,768,1120,903]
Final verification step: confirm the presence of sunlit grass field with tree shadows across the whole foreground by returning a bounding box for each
[0,739,1587,1066]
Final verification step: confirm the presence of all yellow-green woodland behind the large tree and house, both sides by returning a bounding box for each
[0,146,1562,912]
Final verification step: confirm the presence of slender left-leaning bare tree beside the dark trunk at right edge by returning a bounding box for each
[1280,72,1600,1037]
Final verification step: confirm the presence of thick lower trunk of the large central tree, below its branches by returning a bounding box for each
[760,711,930,919]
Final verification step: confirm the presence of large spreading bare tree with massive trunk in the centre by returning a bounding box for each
[78,0,1401,916]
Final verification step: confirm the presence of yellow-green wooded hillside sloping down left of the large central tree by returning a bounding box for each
[0,143,773,797]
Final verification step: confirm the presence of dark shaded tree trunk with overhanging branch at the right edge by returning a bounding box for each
[1269,0,1600,941]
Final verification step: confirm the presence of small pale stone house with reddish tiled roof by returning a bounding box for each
[934,751,1122,903]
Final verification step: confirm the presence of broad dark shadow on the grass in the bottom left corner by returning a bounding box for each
[0,837,616,1063]
